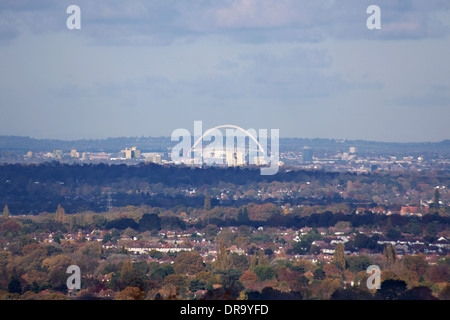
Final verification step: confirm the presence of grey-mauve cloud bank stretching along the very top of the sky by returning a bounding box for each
[0,0,450,46]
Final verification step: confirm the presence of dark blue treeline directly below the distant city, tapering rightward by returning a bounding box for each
[0,161,344,187]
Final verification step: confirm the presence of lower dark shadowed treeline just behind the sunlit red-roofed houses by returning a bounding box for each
[95,207,450,244]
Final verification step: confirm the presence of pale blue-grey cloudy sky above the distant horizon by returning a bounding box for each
[0,0,450,142]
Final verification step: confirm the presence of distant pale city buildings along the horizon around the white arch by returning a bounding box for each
[4,138,450,173]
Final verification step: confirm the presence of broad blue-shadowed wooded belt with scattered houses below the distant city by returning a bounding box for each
[0,162,450,215]
